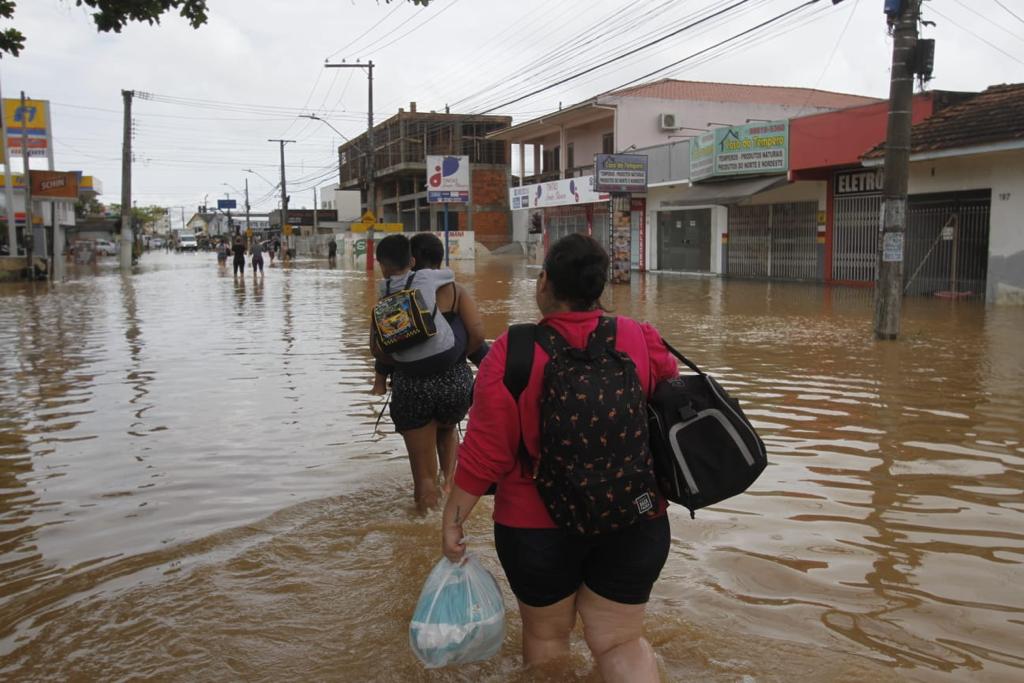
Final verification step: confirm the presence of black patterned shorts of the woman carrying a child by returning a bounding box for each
[391,360,473,432]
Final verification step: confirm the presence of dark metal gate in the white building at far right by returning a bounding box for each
[903,190,991,297]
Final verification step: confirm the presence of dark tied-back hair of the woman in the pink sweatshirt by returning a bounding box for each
[544,232,608,310]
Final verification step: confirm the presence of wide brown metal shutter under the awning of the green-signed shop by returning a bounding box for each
[728,202,820,280]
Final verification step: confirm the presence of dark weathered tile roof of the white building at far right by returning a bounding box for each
[864,83,1024,159]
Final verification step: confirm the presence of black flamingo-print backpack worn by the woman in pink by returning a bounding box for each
[505,317,659,536]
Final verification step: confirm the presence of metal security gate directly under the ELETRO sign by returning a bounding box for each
[831,195,882,283]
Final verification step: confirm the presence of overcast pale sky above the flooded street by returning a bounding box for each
[0,0,1024,215]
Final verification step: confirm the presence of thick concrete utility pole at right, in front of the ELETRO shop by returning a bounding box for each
[874,0,922,339]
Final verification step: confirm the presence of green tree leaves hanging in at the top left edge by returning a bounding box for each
[0,0,430,57]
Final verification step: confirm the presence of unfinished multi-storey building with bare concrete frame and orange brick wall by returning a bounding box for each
[338,102,512,248]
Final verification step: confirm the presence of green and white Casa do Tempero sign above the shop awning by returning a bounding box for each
[690,121,790,180]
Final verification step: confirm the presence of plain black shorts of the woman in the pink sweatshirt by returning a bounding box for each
[495,515,671,607]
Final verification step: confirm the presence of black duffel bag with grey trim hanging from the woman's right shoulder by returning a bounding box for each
[648,339,768,517]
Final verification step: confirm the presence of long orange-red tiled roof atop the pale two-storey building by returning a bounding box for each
[610,78,882,110]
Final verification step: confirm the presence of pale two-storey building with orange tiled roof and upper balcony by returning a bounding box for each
[487,79,877,272]
